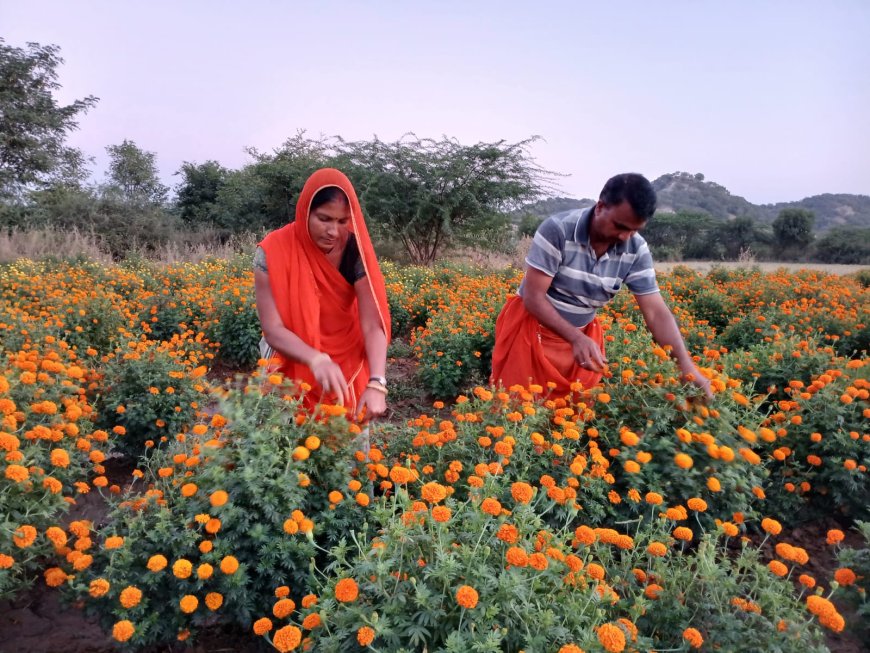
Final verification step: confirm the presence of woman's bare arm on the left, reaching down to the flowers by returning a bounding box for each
[254,269,347,404]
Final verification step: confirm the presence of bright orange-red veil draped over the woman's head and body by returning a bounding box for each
[260,168,390,410]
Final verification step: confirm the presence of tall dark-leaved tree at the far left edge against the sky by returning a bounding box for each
[0,38,98,199]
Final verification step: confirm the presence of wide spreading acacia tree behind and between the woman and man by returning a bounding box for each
[335,134,555,264]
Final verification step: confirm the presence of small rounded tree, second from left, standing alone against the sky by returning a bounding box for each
[106,139,169,206]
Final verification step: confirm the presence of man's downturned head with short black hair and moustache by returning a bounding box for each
[591,172,656,246]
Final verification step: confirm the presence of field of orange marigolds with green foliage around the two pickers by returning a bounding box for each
[0,258,870,653]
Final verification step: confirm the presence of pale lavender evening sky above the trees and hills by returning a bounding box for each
[0,0,870,204]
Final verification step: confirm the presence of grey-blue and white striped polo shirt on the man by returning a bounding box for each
[517,206,659,327]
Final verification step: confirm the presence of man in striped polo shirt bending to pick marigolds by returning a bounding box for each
[491,173,712,398]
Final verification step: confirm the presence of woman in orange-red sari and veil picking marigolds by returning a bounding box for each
[254,168,390,418]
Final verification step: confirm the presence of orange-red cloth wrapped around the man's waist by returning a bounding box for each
[490,295,604,395]
